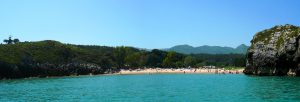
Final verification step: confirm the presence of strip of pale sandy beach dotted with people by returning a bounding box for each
[116,68,243,74]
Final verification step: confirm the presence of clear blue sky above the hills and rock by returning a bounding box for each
[0,0,300,48]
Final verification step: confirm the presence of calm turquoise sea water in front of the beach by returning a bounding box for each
[0,74,300,102]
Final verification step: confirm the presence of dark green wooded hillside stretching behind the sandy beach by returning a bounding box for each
[0,40,245,79]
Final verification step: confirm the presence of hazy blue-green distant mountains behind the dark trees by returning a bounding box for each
[162,44,249,54]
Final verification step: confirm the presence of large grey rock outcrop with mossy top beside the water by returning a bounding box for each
[244,25,300,76]
